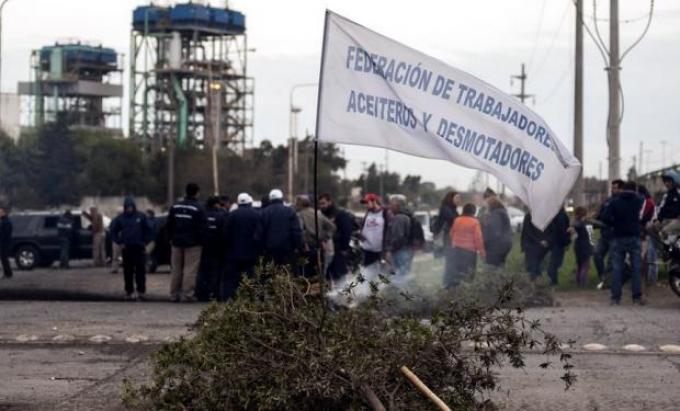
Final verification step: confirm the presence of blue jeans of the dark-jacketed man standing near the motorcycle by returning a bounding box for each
[611,236,642,301]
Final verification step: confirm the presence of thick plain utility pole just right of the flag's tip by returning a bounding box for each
[572,0,586,205]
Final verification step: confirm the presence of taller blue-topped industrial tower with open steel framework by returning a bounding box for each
[129,3,253,152]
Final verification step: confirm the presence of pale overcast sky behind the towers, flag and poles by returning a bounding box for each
[2,0,680,192]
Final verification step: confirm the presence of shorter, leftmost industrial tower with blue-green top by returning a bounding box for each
[19,41,123,129]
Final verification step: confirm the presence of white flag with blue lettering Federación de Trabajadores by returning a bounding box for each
[317,11,581,229]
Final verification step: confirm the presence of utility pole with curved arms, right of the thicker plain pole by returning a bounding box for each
[607,0,621,181]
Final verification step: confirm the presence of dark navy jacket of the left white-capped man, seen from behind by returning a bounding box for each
[224,204,262,261]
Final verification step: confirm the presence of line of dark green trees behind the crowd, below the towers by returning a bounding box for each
[0,122,452,209]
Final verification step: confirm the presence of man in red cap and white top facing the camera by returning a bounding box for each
[360,193,389,267]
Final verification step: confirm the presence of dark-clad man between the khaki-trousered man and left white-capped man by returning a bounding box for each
[196,197,225,301]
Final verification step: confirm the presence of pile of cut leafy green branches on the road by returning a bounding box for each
[123,266,575,410]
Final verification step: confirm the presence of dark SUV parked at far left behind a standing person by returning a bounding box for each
[11,212,92,270]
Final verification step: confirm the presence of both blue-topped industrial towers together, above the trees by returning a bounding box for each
[12,2,254,153]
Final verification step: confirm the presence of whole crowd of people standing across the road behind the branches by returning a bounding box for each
[0,171,680,304]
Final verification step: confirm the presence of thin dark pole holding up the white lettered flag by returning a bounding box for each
[313,9,330,302]
